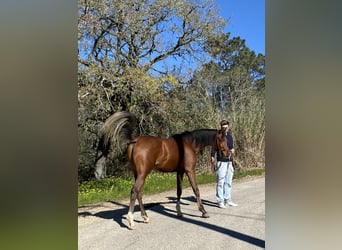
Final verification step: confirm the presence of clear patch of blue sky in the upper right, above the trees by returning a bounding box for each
[216,0,265,55]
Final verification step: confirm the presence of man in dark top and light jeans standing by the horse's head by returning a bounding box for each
[211,120,238,208]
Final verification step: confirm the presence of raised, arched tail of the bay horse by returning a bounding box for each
[101,111,136,151]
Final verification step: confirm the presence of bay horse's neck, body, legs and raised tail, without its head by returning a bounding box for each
[102,111,217,229]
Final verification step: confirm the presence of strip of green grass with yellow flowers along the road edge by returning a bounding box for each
[78,168,265,207]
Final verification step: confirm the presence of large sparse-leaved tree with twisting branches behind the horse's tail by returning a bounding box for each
[78,0,225,178]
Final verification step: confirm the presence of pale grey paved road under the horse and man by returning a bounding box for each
[78,177,265,250]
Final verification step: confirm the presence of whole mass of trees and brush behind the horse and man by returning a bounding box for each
[78,0,265,181]
